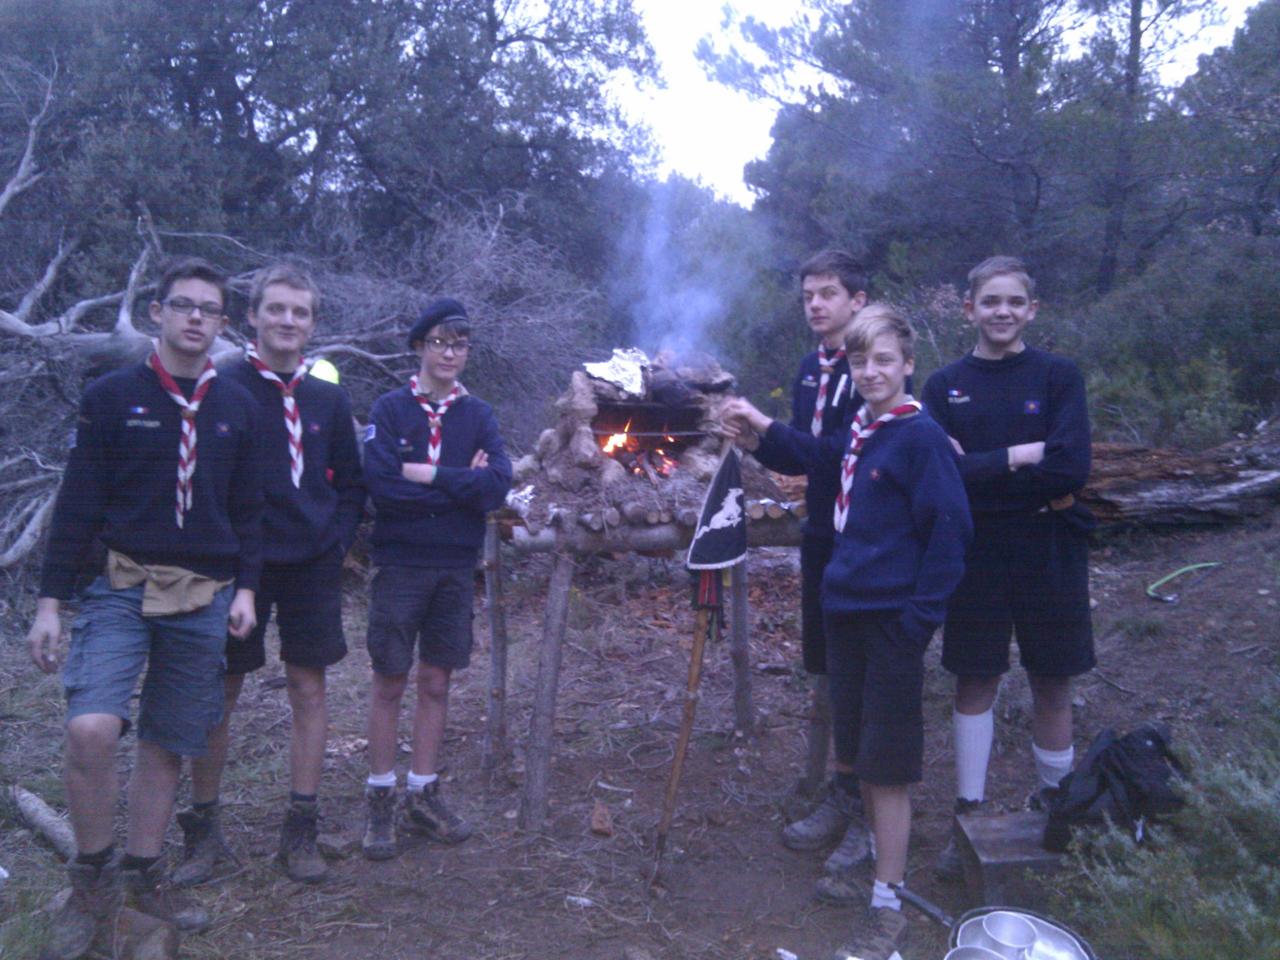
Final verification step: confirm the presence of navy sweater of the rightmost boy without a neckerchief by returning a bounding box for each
[923,347,1092,513]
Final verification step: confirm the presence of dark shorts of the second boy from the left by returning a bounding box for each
[227,547,347,675]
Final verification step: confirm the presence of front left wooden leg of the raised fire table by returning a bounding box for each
[520,552,573,831]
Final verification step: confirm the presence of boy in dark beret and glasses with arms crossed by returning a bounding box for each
[362,298,511,860]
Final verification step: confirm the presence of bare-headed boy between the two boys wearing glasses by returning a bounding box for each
[173,264,365,884]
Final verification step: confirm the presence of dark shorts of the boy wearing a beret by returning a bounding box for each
[367,566,475,677]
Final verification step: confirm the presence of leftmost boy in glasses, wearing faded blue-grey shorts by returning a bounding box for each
[28,259,262,960]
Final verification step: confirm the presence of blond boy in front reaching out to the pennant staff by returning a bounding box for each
[730,305,973,960]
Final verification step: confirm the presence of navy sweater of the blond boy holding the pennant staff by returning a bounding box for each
[764,413,973,643]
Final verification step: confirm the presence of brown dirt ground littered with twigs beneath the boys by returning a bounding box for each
[0,511,1280,960]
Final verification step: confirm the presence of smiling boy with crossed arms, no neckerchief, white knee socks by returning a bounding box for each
[924,256,1094,877]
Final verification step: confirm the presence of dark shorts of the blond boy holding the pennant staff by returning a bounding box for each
[827,613,932,786]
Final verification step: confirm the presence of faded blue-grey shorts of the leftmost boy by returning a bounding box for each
[63,577,234,756]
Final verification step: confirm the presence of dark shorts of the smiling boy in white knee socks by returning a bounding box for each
[942,511,1097,677]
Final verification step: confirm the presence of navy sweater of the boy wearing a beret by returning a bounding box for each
[365,387,511,567]
